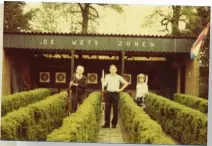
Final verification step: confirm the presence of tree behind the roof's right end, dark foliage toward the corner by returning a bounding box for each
[141,6,210,37]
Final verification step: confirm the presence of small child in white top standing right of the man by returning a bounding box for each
[135,74,149,107]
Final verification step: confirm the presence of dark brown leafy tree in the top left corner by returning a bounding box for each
[4,2,34,32]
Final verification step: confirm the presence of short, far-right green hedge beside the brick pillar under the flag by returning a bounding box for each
[173,93,208,114]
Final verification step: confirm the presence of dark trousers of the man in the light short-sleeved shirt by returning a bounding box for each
[104,91,119,126]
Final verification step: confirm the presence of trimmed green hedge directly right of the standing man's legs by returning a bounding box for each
[119,93,176,144]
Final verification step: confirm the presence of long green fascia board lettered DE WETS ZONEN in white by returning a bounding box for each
[4,33,195,53]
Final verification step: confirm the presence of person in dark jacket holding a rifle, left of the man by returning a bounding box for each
[70,65,87,113]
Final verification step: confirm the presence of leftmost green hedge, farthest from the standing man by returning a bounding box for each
[1,89,51,117]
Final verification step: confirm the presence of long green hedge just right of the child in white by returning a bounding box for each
[146,92,208,145]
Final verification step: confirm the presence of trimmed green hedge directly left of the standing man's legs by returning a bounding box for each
[47,92,101,142]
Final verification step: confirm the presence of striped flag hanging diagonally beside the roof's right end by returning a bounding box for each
[190,23,210,59]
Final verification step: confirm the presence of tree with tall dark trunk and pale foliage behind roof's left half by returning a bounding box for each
[30,2,123,33]
